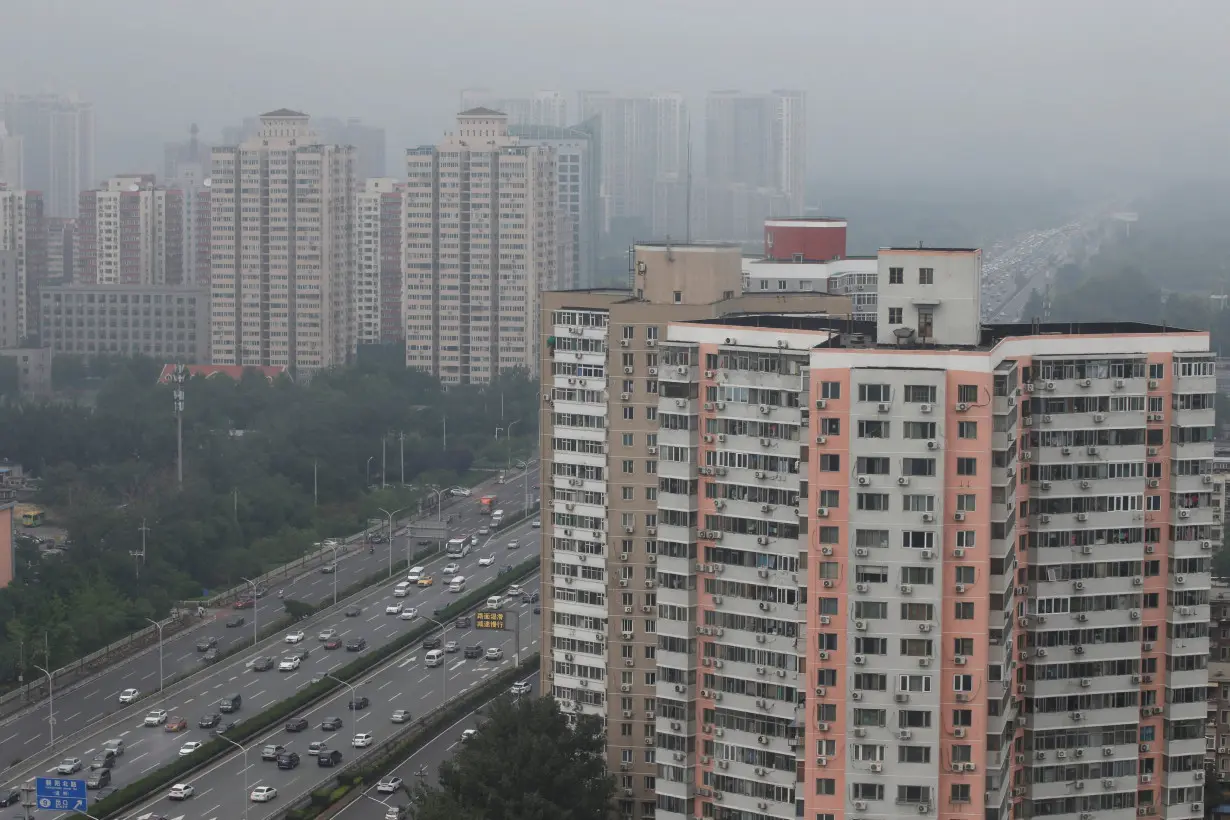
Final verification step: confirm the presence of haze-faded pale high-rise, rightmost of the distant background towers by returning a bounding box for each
[705,91,807,240]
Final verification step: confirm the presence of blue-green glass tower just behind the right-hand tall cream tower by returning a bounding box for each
[508,119,601,289]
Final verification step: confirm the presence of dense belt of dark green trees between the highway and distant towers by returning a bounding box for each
[0,359,539,684]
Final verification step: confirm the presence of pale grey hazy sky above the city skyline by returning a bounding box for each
[0,0,1230,188]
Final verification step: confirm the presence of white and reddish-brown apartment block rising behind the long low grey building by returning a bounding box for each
[74,173,185,285]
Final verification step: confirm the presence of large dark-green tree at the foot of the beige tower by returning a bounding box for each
[413,697,615,820]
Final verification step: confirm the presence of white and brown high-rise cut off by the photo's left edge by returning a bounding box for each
[0,186,47,343]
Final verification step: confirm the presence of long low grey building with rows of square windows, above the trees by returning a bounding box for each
[39,285,210,364]
